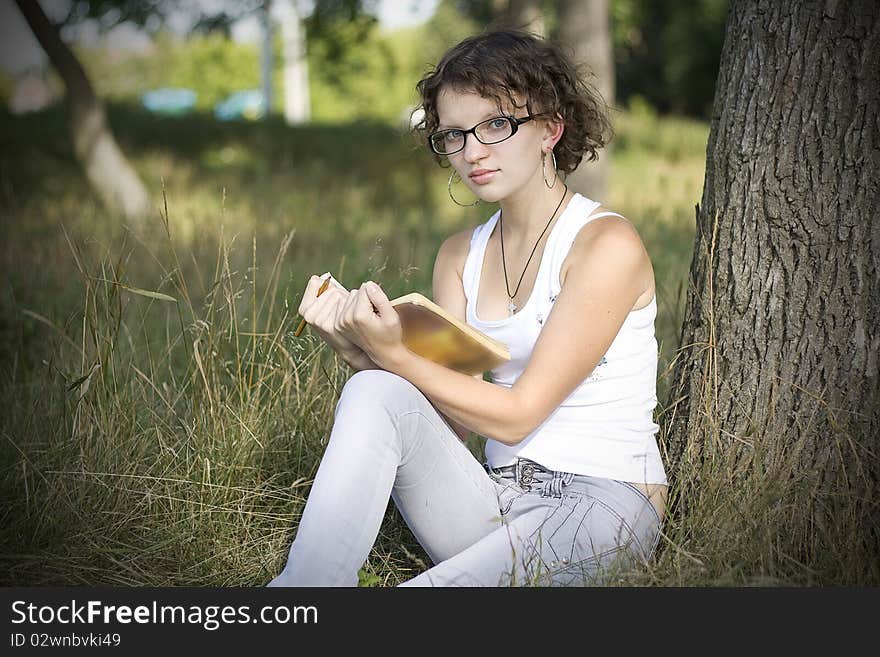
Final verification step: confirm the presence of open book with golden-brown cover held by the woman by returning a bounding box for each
[325,274,510,375]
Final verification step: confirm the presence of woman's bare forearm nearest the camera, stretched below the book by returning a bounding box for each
[385,350,529,445]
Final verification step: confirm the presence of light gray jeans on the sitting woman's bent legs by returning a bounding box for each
[269,370,660,586]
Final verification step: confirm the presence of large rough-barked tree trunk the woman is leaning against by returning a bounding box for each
[661,0,880,560]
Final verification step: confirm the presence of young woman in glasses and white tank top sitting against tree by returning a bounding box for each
[270,31,666,586]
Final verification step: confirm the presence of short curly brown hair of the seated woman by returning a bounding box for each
[415,29,613,173]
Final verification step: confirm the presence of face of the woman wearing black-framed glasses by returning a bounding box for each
[437,88,563,202]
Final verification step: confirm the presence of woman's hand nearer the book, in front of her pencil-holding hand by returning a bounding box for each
[336,281,408,371]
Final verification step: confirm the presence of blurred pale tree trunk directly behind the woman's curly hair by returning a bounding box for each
[558,0,614,201]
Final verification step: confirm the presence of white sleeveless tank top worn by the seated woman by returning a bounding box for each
[462,194,667,484]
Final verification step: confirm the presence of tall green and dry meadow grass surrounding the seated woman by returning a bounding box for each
[0,101,880,586]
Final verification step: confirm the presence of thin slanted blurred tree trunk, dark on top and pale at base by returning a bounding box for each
[15,0,150,225]
